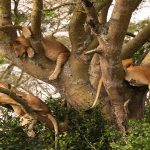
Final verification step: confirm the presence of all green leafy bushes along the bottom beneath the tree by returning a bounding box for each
[0,98,150,150]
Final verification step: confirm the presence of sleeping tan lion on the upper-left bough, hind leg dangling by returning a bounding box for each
[11,35,70,80]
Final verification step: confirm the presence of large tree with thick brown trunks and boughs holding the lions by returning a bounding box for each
[0,0,150,132]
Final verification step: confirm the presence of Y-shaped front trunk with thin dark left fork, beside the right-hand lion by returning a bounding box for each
[82,0,141,132]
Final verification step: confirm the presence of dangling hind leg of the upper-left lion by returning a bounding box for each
[49,53,69,80]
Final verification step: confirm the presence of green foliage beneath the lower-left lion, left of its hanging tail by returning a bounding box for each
[0,106,54,150]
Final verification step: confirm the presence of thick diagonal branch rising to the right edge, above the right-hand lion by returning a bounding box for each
[121,24,150,59]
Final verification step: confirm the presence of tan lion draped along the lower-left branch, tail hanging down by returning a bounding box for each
[0,83,58,137]
